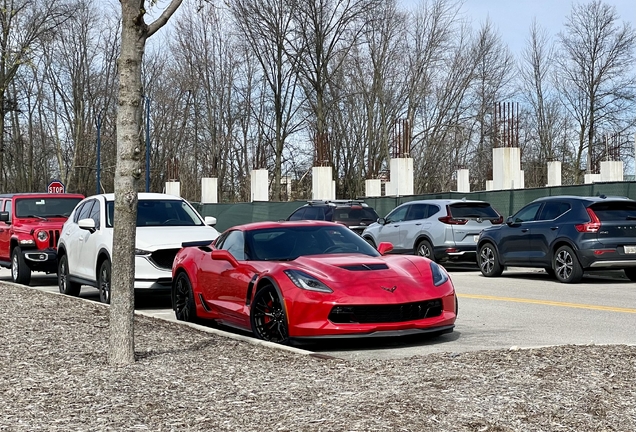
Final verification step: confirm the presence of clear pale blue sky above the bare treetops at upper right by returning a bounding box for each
[401,0,636,54]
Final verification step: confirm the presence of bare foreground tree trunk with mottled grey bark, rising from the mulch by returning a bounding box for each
[109,0,182,365]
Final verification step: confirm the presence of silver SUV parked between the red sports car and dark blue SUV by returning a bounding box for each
[362,199,503,262]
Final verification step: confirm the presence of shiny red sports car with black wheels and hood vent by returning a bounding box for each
[172,221,457,343]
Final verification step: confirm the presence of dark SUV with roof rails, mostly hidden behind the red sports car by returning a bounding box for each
[287,200,379,234]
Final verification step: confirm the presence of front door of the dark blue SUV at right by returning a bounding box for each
[497,202,543,264]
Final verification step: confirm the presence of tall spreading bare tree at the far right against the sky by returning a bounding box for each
[556,0,636,183]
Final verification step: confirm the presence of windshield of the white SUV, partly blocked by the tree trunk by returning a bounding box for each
[106,200,204,228]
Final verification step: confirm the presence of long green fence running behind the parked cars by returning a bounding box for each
[194,181,636,231]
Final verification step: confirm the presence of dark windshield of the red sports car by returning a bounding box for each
[245,225,380,261]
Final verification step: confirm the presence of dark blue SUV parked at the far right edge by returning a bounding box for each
[477,195,636,283]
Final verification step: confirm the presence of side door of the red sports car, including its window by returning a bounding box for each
[200,230,254,328]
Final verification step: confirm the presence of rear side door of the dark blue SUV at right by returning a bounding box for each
[528,201,571,267]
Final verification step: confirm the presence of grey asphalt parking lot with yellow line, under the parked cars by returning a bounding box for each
[0,268,636,359]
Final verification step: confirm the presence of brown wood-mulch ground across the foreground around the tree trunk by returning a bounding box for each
[0,284,636,432]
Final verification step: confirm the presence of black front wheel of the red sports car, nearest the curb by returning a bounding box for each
[250,285,289,344]
